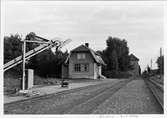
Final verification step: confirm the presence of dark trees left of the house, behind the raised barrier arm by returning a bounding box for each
[4,33,68,77]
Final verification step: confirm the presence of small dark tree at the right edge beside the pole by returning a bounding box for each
[156,56,164,74]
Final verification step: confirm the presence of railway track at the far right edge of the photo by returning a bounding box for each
[145,79,164,110]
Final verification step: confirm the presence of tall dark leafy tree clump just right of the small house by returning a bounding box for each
[97,36,133,77]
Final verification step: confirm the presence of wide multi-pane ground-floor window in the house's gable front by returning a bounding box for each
[74,64,89,72]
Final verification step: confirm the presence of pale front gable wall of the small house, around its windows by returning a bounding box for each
[69,53,96,79]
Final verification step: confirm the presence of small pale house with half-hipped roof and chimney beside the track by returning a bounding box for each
[62,43,105,79]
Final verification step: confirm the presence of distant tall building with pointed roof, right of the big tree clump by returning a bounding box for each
[130,54,140,76]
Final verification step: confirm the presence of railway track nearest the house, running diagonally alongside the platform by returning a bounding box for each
[4,80,131,114]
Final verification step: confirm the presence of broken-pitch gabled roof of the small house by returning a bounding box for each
[65,45,106,65]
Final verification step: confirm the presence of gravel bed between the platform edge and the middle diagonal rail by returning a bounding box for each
[4,80,124,114]
